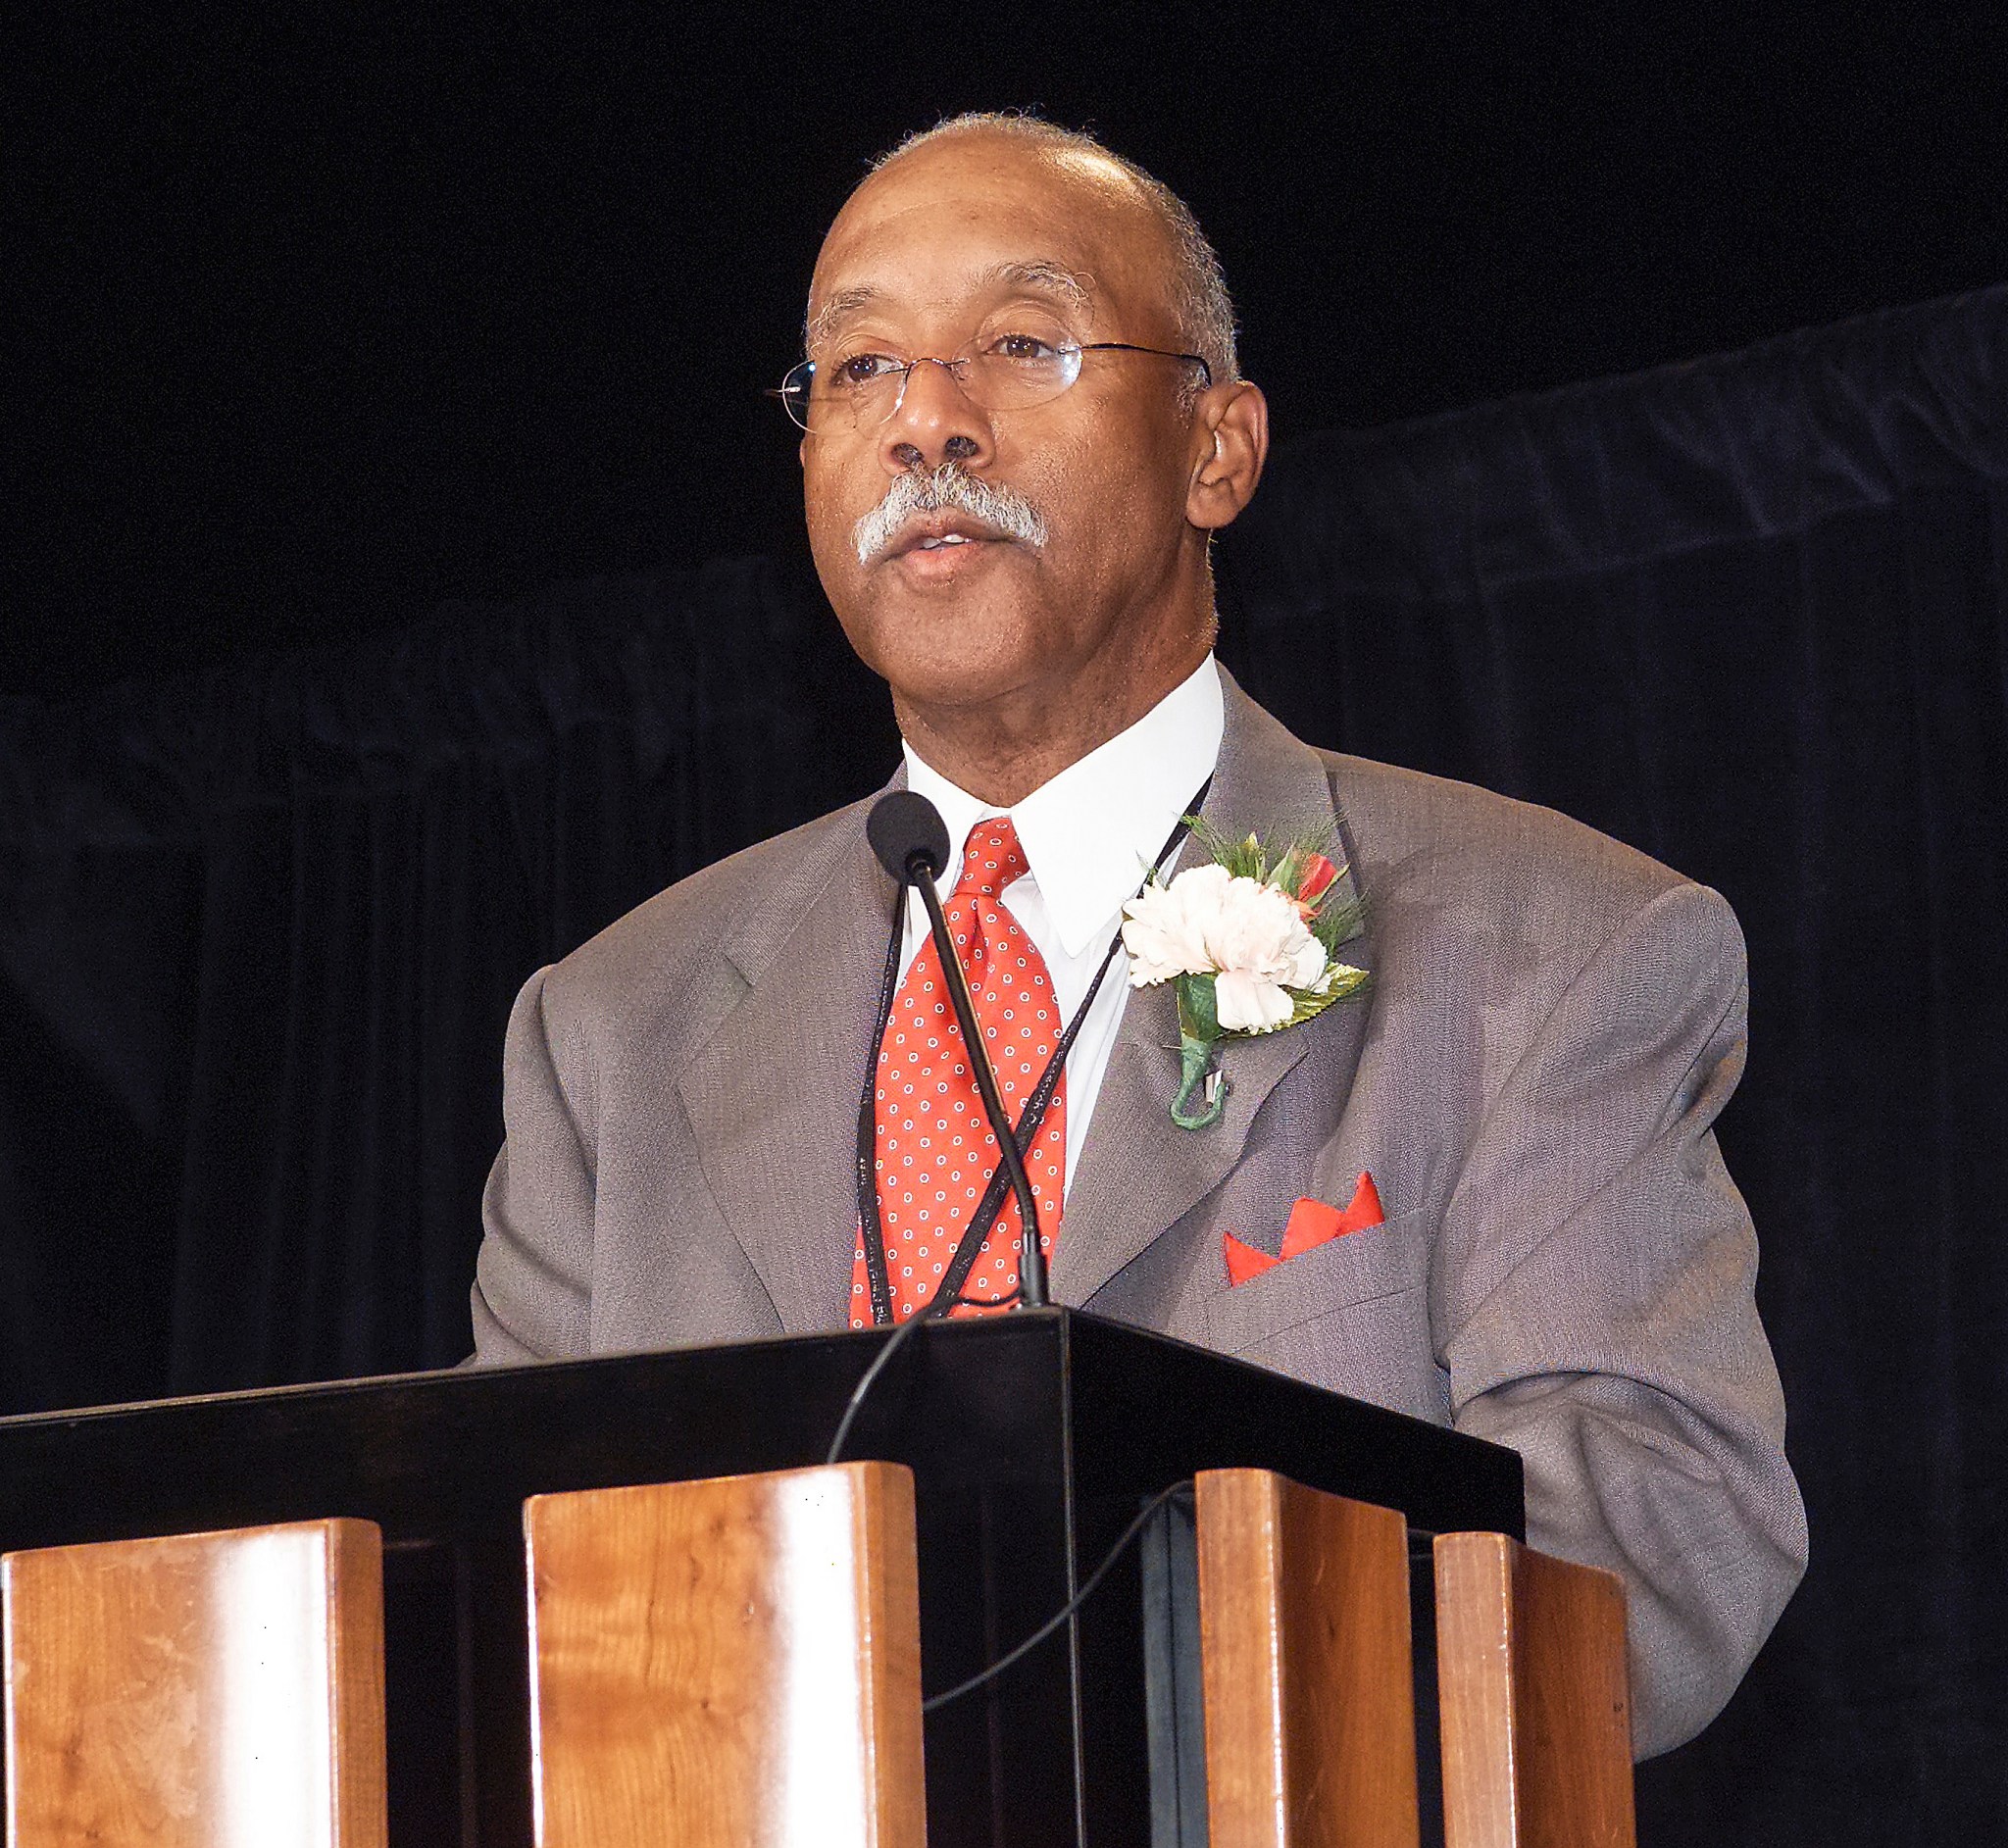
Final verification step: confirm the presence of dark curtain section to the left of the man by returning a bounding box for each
[0,561,893,1410]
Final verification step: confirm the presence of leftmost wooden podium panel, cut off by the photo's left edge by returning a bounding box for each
[0,1521,385,1848]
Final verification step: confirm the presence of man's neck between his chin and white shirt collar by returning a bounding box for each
[893,637,1213,808]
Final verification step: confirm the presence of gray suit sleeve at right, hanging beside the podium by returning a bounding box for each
[1431,886,1805,1758]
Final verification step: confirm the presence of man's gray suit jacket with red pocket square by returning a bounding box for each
[474,683,1805,1754]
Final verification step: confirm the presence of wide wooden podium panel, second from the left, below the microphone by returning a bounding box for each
[525,1463,926,1848]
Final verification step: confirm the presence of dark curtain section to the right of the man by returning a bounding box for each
[1225,289,2008,1844]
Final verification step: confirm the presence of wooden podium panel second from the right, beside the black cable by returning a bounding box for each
[1195,1469,1420,1848]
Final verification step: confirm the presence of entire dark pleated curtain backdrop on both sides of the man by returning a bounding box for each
[0,291,2008,1848]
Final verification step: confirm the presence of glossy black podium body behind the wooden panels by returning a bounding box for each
[0,1310,1522,1848]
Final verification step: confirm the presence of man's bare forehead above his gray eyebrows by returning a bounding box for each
[809,134,1173,339]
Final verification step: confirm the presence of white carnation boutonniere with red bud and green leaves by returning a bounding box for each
[1123,816,1368,1128]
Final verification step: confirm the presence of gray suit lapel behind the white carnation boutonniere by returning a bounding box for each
[1052,669,1366,1304]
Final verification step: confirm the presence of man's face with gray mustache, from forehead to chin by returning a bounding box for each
[801,134,1230,713]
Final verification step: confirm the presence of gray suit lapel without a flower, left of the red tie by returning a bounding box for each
[677,787,893,1333]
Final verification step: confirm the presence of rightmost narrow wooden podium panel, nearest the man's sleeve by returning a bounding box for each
[1435,1532,1636,1848]
